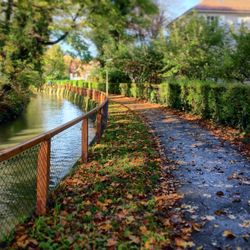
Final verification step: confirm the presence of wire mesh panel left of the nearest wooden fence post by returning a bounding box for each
[0,144,40,235]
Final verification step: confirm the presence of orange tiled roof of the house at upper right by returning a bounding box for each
[194,0,250,12]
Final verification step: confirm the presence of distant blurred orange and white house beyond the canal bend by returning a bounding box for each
[69,58,100,81]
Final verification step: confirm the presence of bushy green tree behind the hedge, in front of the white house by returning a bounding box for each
[164,13,225,79]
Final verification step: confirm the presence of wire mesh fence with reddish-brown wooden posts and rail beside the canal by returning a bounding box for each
[0,87,108,241]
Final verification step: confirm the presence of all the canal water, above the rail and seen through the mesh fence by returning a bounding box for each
[0,95,95,235]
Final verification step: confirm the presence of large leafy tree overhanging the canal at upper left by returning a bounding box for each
[0,0,83,91]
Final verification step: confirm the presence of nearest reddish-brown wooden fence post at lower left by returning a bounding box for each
[36,139,51,215]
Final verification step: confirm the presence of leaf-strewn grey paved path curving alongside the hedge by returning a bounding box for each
[112,96,250,249]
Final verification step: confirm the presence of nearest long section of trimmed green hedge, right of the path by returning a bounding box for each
[160,80,250,131]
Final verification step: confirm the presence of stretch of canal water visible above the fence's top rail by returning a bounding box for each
[0,95,93,150]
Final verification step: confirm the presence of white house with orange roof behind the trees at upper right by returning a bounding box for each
[171,0,250,30]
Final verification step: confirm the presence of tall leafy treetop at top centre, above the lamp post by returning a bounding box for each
[86,0,158,60]
